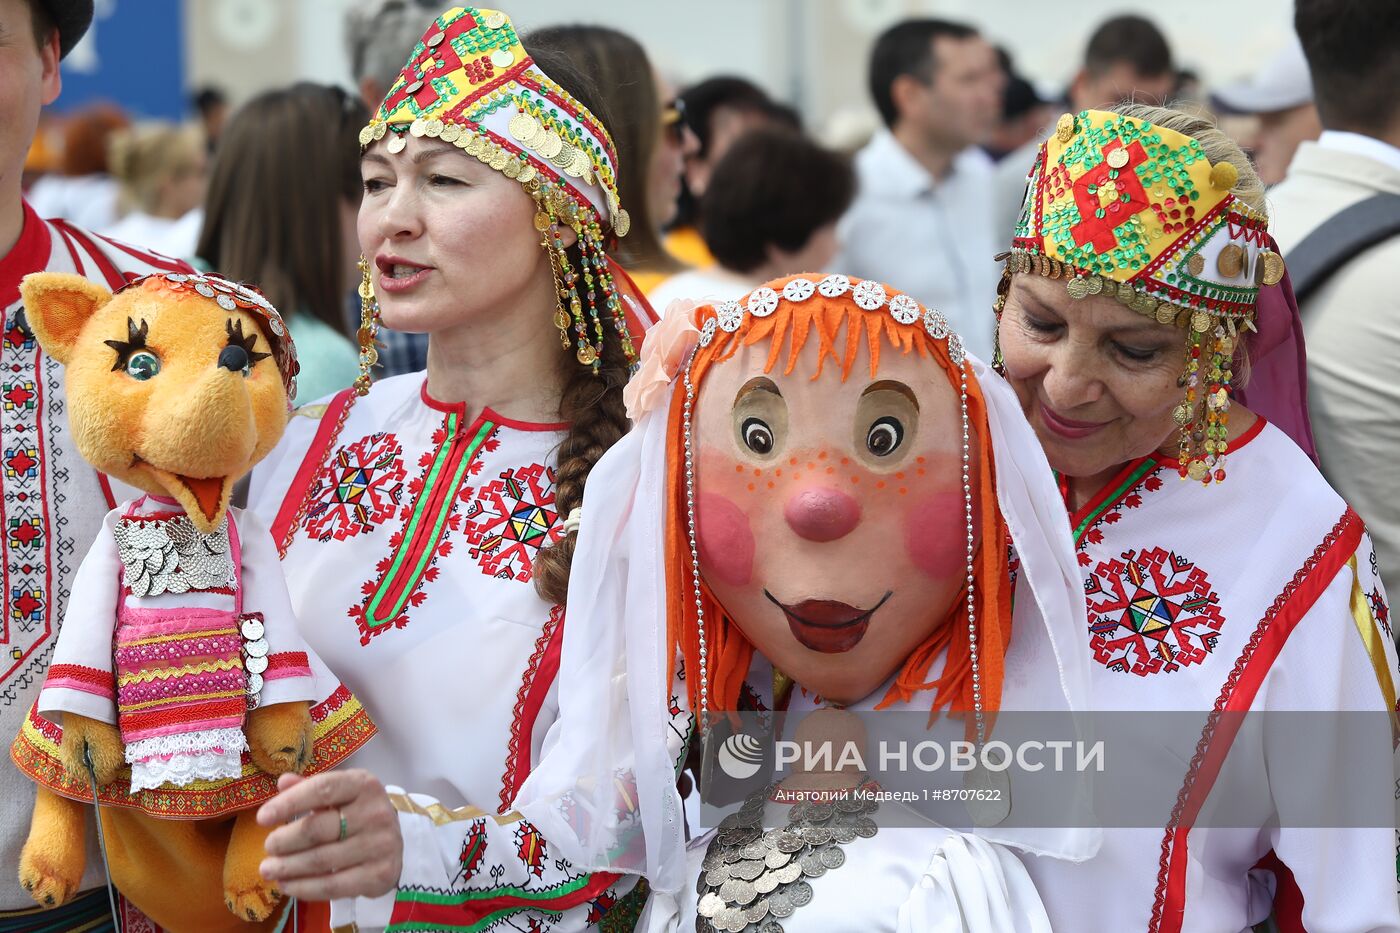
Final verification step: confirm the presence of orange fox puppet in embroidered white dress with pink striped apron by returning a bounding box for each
[11,273,372,930]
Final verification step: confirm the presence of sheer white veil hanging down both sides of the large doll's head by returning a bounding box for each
[515,348,1099,894]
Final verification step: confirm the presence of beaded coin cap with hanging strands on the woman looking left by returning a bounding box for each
[360,7,636,370]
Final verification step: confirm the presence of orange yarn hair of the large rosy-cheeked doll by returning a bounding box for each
[665,276,1011,727]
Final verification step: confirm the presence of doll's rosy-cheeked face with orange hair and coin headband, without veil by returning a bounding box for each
[668,275,1007,709]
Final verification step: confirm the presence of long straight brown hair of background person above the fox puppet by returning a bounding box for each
[196,83,370,333]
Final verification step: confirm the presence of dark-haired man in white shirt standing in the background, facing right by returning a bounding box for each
[834,20,1005,359]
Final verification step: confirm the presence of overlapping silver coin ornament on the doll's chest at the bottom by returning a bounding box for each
[696,786,879,933]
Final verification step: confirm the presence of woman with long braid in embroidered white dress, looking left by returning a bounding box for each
[243,7,663,930]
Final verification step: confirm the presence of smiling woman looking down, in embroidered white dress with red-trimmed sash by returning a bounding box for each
[998,108,1400,933]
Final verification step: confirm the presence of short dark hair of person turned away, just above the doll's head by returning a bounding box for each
[700,127,855,272]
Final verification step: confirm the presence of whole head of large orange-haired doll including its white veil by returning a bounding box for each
[517,275,1093,892]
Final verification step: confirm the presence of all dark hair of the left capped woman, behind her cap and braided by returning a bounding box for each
[526,43,632,605]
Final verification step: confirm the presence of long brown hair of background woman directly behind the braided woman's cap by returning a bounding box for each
[524,25,680,272]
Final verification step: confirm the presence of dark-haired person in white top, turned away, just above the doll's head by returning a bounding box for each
[647,126,855,314]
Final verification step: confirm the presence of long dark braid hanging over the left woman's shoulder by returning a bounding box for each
[535,319,630,605]
